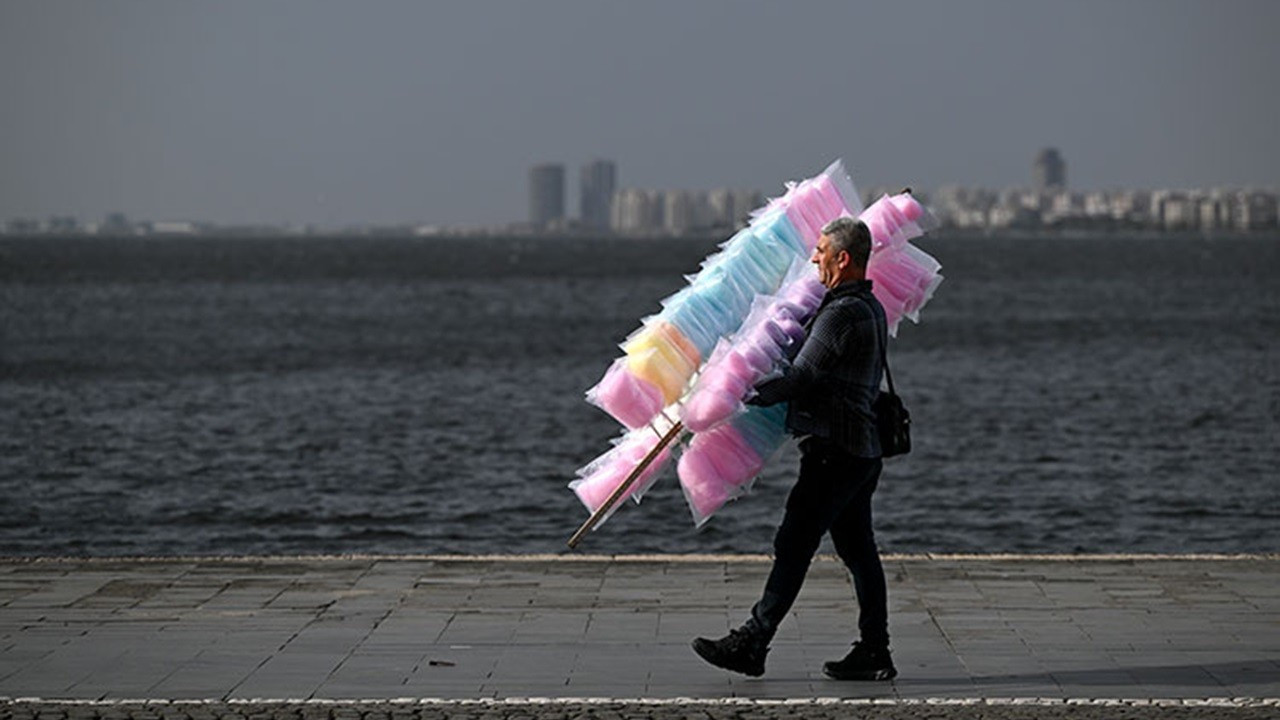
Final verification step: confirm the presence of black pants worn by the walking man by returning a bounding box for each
[748,438,888,647]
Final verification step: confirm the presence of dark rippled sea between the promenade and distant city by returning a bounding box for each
[0,236,1280,556]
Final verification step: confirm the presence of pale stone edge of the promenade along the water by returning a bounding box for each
[0,552,1280,565]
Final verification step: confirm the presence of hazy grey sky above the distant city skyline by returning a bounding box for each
[0,0,1280,224]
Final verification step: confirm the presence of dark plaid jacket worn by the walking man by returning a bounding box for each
[751,281,888,457]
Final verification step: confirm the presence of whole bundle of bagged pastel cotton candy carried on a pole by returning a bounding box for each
[570,160,941,532]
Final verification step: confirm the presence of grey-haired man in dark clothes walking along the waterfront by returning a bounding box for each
[694,212,897,680]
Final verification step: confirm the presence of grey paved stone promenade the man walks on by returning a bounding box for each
[0,555,1280,720]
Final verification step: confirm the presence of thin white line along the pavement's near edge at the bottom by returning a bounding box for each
[0,697,1280,708]
